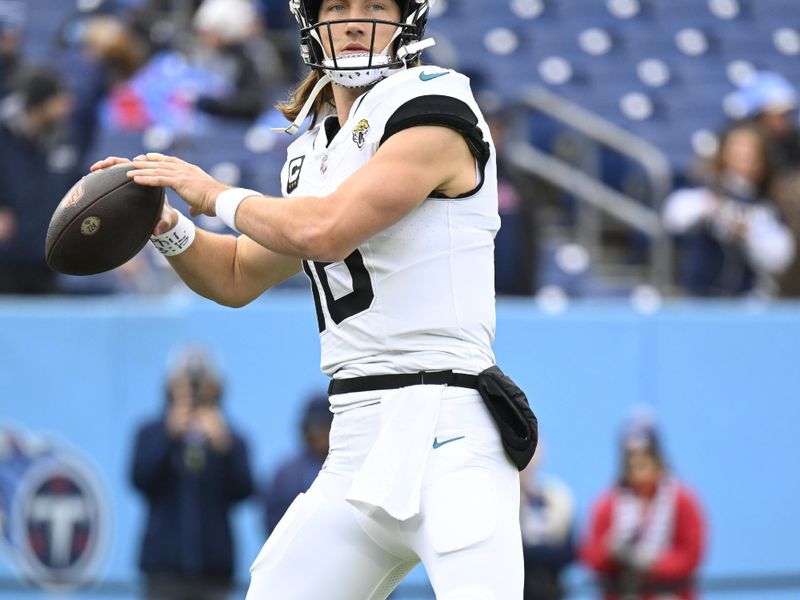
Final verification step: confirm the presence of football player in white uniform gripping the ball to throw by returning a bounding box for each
[93,0,523,600]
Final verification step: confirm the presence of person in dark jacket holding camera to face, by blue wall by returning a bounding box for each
[132,348,253,600]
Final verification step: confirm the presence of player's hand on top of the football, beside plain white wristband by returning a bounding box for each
[128,152,229,217]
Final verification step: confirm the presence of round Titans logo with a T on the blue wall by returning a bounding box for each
[0,430,109,590]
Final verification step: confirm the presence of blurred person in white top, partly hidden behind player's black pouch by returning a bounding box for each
[520,440,575,600]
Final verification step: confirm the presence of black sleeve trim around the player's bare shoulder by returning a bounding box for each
[380,95,491,198]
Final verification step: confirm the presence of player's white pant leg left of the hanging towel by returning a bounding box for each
[246,409,418,600]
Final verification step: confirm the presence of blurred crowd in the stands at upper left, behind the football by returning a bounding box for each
[0,0,299,294]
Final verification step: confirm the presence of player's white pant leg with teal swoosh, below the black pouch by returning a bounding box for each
[409,392,524,600]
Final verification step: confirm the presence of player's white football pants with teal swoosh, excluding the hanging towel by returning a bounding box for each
[247,387,523,600]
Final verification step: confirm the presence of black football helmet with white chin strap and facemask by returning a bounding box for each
[289,0,435,88]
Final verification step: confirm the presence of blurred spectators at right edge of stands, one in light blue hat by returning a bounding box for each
[663,72,800,297]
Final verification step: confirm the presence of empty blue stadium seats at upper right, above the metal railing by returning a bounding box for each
[433,0,800,169]
